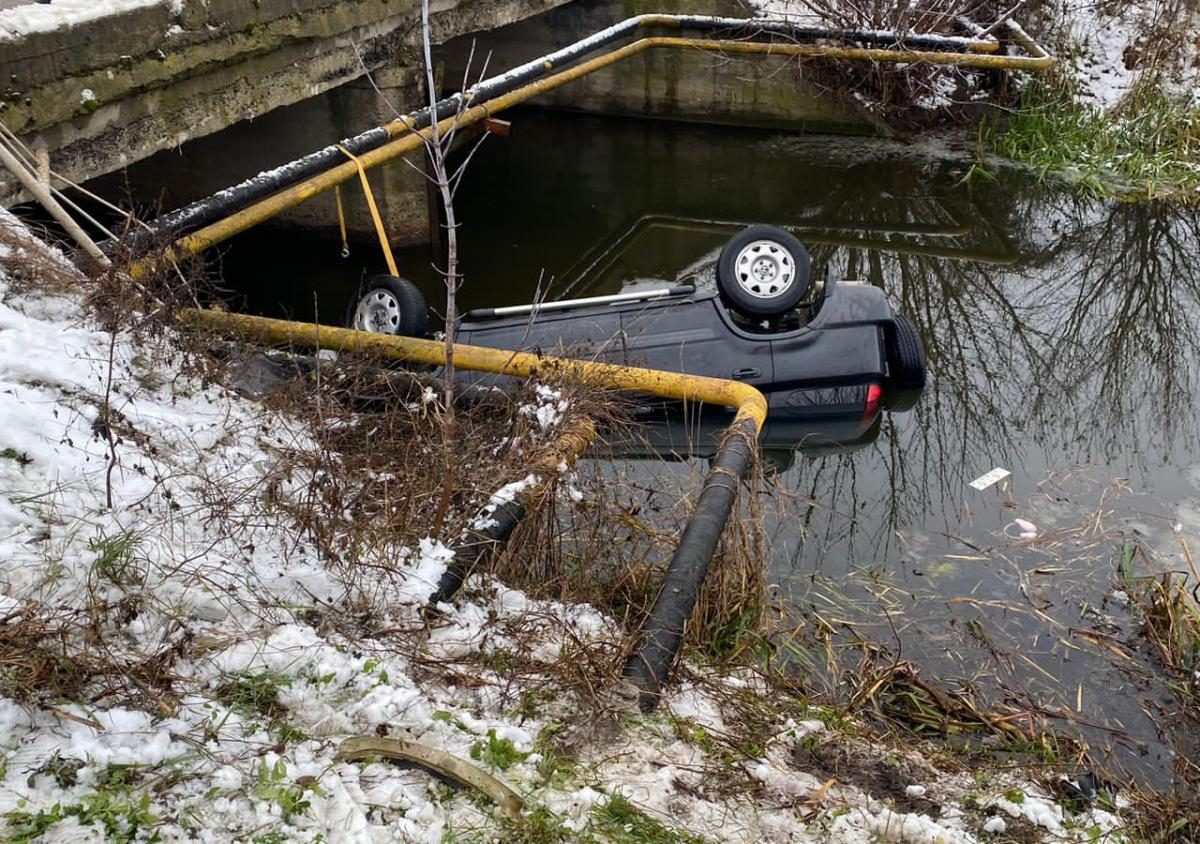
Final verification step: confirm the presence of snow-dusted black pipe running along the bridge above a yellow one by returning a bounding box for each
[129,14,985,249]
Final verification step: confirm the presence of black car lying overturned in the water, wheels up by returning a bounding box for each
[348,226,925,439]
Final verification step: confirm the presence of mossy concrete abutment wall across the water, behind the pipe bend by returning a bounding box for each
[439,0,878,133]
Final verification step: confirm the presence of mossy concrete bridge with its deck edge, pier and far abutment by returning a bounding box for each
[0,0,872,243]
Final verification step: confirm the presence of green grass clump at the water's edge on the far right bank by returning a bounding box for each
[980,79,1200,200]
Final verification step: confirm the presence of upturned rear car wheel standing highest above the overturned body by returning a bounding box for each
[716,226,811,318]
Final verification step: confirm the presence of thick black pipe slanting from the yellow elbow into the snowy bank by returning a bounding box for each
[624,419,757,711]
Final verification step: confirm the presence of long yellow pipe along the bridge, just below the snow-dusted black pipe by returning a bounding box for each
[138,37,1054,277]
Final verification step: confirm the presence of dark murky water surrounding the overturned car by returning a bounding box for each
[218,112,1200,785]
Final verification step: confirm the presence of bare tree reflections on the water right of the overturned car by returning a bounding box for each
[792,181,1200,554]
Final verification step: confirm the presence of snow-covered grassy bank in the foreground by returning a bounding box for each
[0,213,1118,843]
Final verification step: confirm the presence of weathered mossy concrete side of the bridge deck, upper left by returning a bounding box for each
[0,0,565,205]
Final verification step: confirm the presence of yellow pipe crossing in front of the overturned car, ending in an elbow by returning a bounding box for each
[181,309,767,432]
